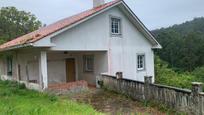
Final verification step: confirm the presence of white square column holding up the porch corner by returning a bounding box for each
[39,51,48,90]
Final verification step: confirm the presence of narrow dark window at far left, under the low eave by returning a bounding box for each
[6,56,13,76]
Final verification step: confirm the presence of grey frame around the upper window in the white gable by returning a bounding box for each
[109,15,122,37]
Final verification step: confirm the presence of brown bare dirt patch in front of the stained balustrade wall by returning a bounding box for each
[64,88,165,115]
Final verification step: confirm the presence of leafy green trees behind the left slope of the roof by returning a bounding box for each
[0,7,42,43]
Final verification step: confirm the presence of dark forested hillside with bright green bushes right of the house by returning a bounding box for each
[152,18,204,88]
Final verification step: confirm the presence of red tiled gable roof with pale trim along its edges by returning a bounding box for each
[0,0,161,51]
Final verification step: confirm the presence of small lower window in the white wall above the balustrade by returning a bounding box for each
[137,54,145,70]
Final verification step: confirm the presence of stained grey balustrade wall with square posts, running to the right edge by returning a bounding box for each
[100,74,204,115]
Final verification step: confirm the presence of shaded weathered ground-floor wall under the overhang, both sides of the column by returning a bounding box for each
[0,49,108,85]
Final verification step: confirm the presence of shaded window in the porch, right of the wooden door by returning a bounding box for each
[83,55,94,72]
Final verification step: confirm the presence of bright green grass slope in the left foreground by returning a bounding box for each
[0,81,101,115]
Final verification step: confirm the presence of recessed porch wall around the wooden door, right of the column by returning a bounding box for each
[48,52,108,85]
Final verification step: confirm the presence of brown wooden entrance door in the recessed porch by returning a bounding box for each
[66,58,76,82]
